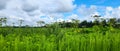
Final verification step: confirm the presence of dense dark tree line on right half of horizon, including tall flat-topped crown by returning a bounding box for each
[46,15,120,28]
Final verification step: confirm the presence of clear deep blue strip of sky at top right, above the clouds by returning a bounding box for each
[74,0,120,7]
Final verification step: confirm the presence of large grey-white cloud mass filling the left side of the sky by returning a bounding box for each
[0,0,76,25]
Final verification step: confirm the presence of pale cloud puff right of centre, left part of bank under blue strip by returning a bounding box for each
[78,5,100,21]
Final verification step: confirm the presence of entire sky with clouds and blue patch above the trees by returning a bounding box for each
[0,0,120,25]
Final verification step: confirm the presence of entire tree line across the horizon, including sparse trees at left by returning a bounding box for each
[0,15,120,28]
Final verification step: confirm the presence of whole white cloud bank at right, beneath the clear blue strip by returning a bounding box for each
[78,5,120,20]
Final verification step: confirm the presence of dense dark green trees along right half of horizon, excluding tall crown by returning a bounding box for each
[59,18,120,28]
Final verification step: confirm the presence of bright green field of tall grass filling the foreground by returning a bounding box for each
[0,28,120,51]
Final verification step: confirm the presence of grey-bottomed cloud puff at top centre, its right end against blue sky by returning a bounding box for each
[40,0,76,13]
